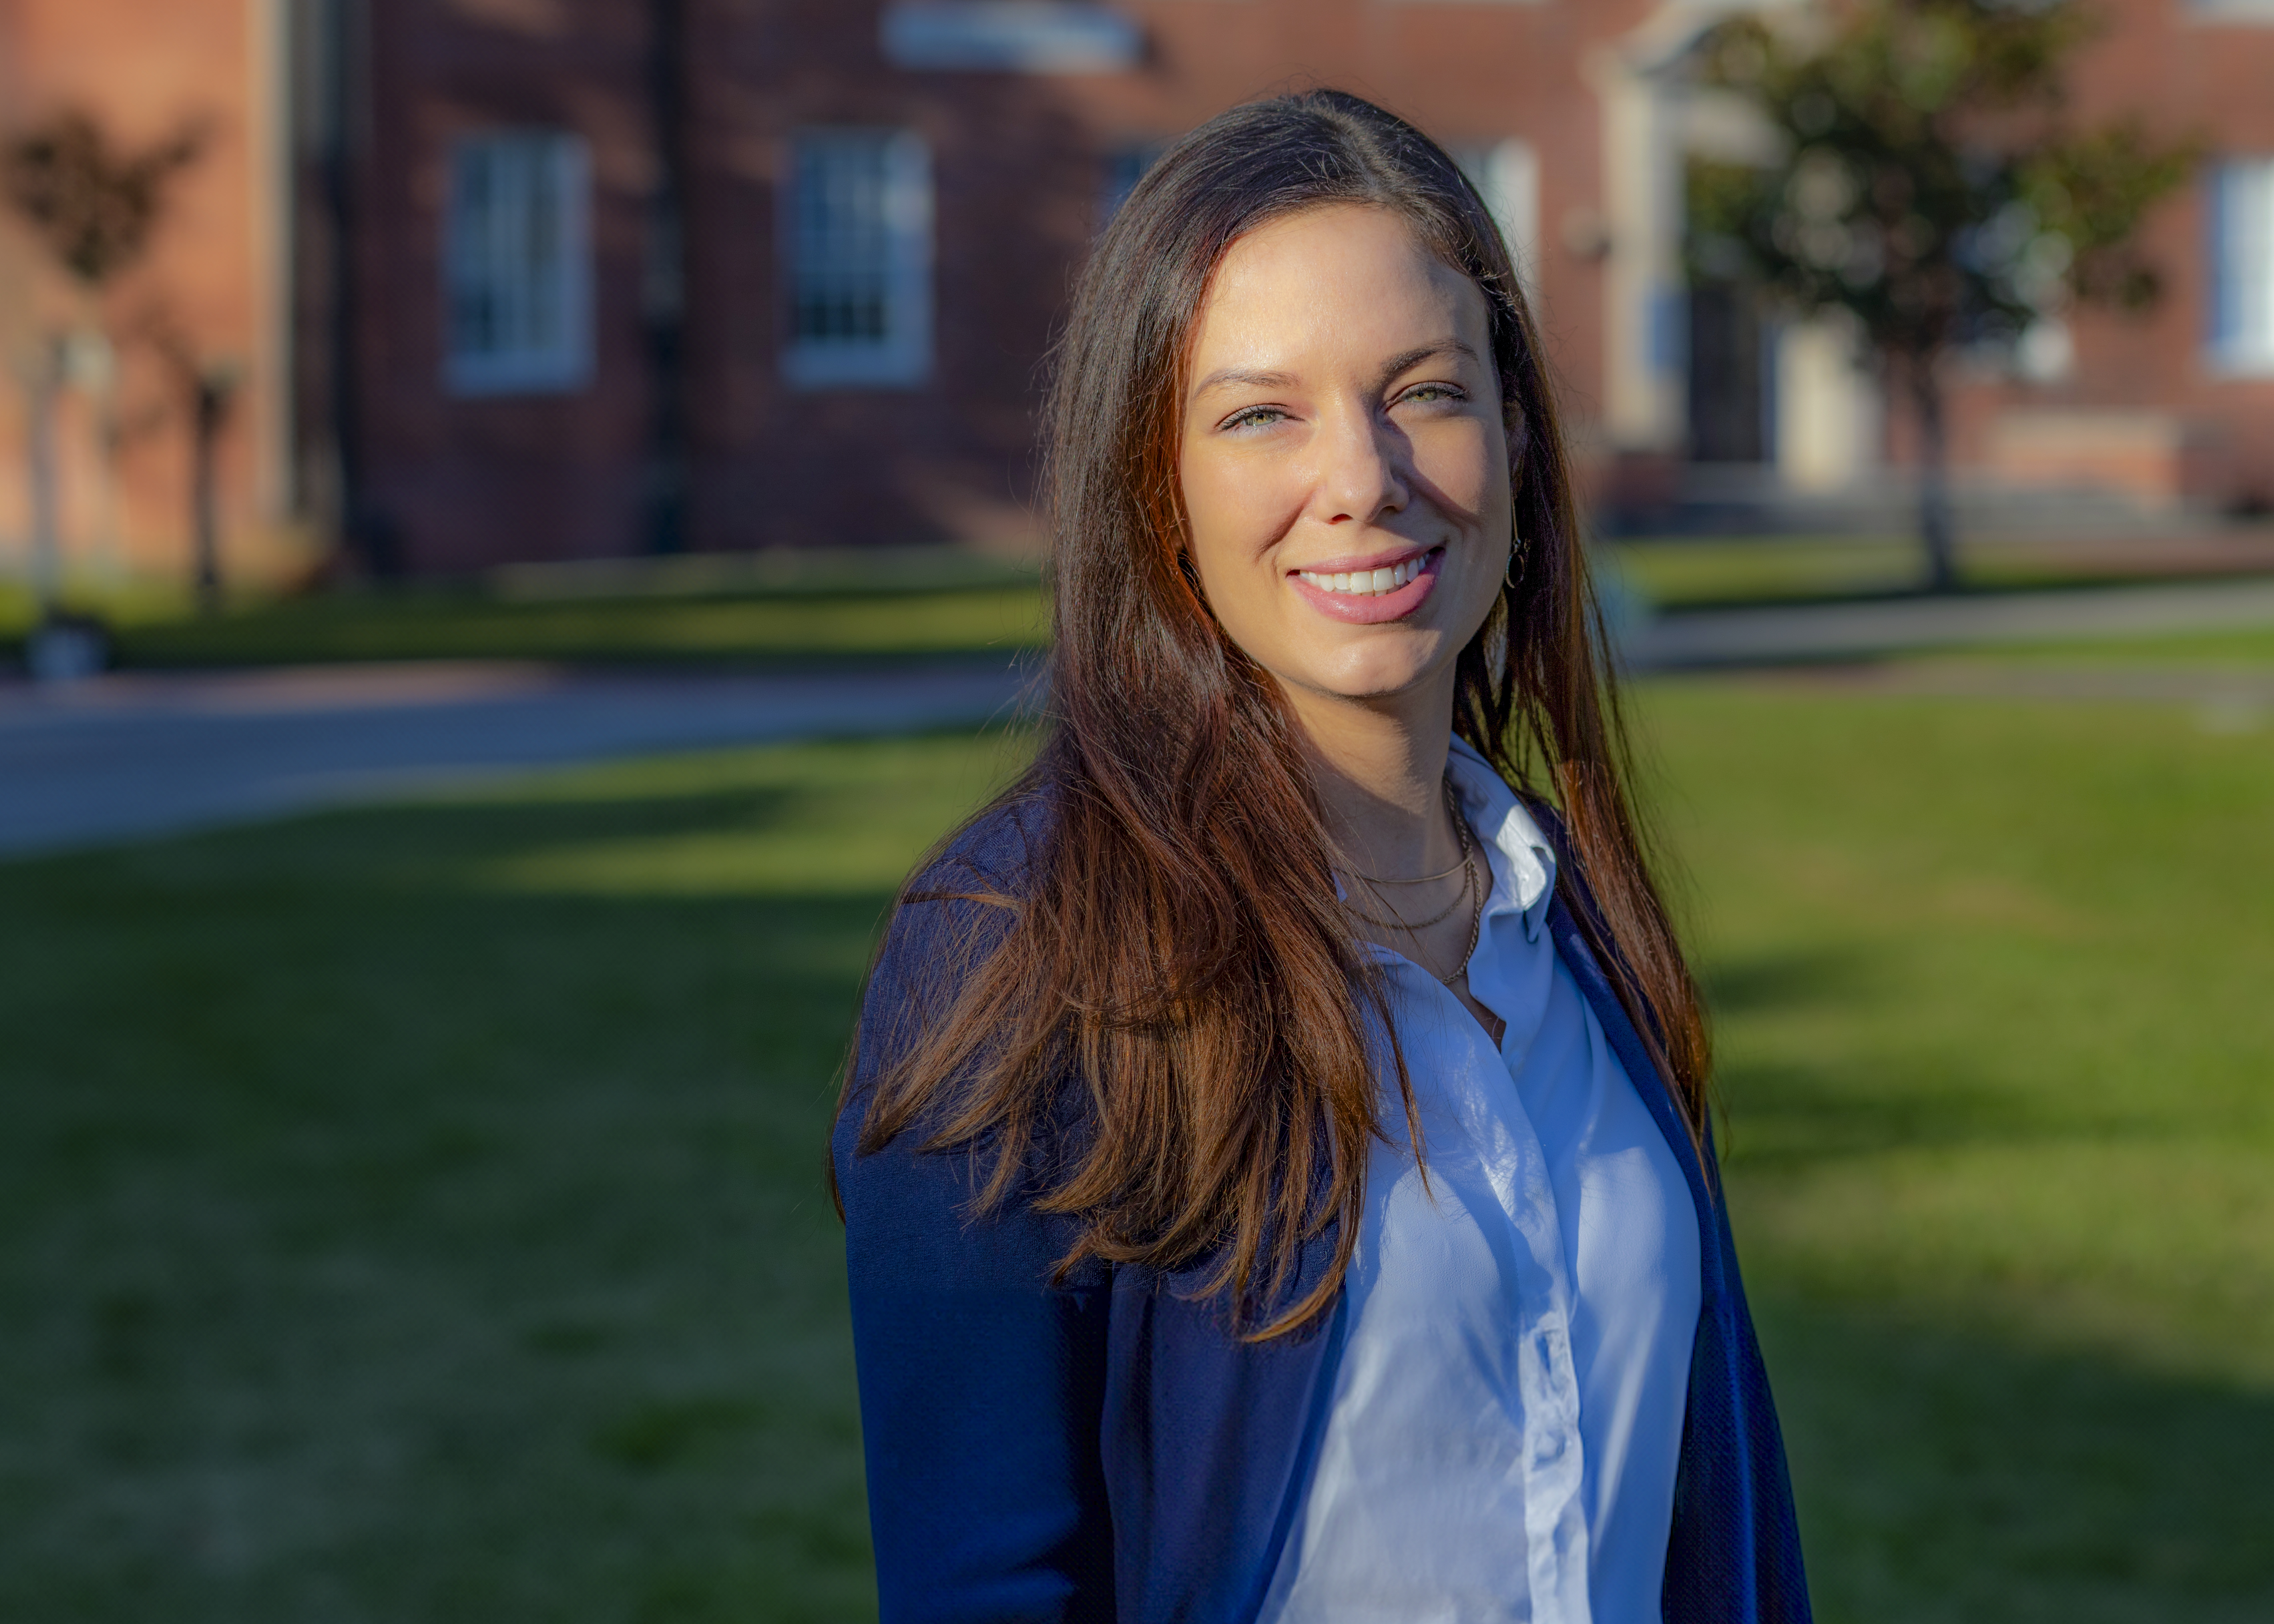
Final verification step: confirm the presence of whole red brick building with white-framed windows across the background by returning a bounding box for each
[13,0,2274,573]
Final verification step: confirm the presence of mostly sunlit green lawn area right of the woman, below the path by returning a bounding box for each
[1646,682,2274,1622]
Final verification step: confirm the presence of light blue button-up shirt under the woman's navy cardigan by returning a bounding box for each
[1262,742,1699,1624]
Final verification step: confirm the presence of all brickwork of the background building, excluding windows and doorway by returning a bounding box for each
[18,0,2274,573]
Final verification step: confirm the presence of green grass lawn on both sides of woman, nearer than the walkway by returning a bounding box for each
[0,682,2274,1624]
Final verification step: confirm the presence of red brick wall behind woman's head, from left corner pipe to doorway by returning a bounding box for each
[346,0,1640,571]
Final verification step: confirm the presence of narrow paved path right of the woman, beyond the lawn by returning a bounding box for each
[1626,580,2274,671]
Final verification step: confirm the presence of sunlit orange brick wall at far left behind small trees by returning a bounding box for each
[0,0,293,575]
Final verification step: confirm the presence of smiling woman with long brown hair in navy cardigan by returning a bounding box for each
[832,93,1808,1624]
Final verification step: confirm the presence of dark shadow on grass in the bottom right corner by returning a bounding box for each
[1753,1285,2274,1624]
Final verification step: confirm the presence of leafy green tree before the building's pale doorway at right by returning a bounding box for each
[1690,0,2195,591]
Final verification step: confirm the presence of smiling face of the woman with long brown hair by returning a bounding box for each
[1178,205,1512,716]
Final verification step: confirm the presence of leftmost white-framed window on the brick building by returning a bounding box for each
[443,130,591,396]
